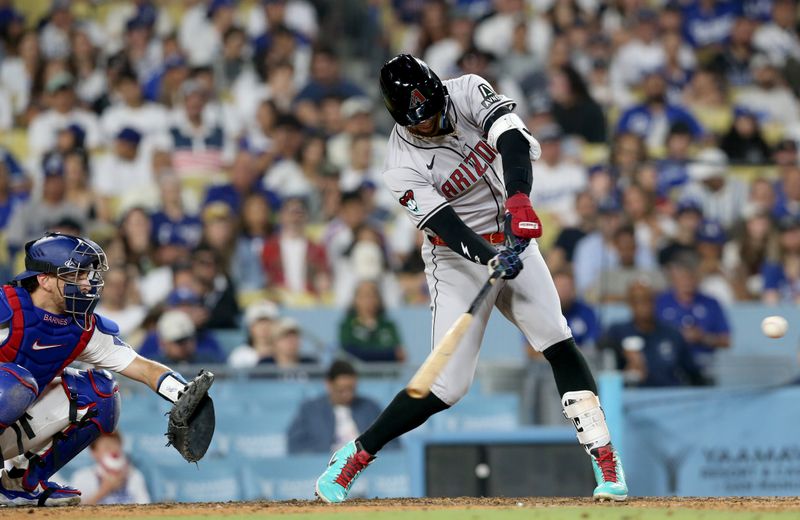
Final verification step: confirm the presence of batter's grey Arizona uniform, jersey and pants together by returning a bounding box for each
[384,75,572,405]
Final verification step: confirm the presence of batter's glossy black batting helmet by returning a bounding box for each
[381,54,447,126]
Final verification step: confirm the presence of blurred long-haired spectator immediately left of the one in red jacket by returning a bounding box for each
[231,193,272,292]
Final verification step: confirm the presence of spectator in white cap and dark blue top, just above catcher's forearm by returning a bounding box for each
[139,309,225,364]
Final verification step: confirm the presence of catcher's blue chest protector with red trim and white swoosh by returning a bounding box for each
[0,285,94,388]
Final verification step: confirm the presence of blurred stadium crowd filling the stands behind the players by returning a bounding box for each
[0,0,800,385]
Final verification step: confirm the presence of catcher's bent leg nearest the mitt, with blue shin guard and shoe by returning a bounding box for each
[0,368,120,506]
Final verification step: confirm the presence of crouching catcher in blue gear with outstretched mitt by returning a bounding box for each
[0,233,214,506]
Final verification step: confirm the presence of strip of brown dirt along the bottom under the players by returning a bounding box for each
[0,497,800,520]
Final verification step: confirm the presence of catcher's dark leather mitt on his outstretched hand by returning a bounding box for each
[167,370,216,462]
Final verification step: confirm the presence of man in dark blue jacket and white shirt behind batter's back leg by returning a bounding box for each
[288,361,384,454]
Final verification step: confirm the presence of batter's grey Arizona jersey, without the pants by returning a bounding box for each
[383,74,514,234]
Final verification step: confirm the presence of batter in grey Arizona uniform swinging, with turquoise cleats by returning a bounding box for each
[316,54,628,502]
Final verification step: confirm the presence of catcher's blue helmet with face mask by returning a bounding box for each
[14,233,108,330]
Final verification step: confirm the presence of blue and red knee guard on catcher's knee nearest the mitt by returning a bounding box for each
[61,368,120,433]
